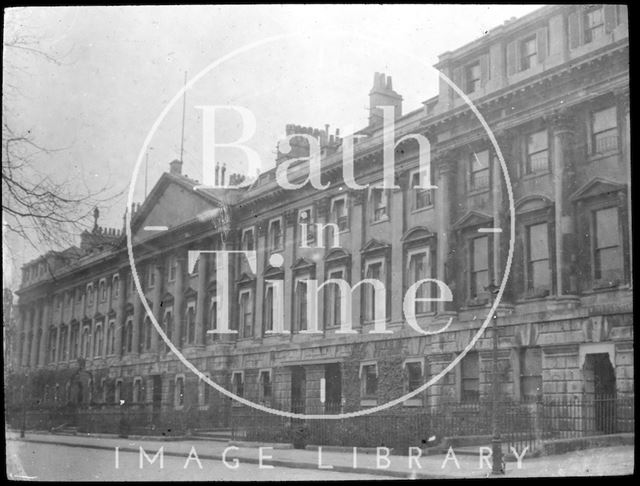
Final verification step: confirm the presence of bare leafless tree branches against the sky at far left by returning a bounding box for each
[2,9,122,270]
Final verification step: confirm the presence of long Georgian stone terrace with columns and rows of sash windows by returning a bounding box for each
[8,5,633,430]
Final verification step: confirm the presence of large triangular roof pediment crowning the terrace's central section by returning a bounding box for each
[131,174,224,244]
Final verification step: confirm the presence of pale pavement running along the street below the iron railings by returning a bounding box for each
[6,431,634,479]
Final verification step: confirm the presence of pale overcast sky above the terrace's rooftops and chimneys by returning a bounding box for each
[3,5,539,287]
